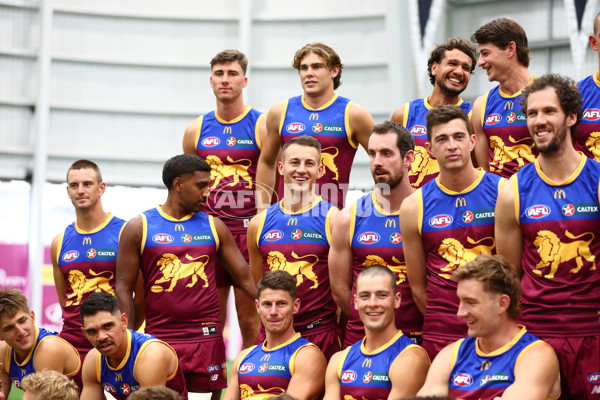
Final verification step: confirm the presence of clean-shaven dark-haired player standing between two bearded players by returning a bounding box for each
[400,105,503,359]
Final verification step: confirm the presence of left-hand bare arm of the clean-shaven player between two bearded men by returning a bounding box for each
[400,192,427,315]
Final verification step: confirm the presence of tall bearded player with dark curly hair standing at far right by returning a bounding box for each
[496,74,600,399]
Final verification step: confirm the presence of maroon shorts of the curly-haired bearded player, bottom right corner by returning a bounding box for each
[540,335,600,400]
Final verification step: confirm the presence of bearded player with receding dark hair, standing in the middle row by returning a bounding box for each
[329,121,423,346]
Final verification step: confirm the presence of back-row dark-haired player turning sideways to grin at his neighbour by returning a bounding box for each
[471,18,537,178]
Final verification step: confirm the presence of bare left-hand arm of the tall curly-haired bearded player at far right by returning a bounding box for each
[494,177,523,277]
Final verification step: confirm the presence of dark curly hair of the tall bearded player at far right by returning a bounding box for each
[521,74,583,138]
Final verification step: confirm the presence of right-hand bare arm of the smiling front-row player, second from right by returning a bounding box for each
[388,347,431,400]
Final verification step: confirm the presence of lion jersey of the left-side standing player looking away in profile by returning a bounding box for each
[140,207,222,343]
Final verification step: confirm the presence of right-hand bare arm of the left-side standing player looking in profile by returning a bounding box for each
[213,218,256,301]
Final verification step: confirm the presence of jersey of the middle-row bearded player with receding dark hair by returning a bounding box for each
[344,192,423,345]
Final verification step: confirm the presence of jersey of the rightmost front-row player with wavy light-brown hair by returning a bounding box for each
[448,327,542,400]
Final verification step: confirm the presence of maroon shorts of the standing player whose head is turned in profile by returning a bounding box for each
[170,339,227,392]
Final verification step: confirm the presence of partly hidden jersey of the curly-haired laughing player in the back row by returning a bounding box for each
[402,98,473,189]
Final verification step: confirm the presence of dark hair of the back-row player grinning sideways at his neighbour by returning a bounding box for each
[471,18,531,67]
